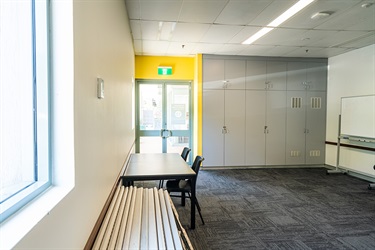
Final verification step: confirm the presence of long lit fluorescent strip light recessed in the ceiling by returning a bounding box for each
[242,0,315,44]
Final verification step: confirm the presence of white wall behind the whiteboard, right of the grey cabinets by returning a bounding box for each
[326,45,375,177]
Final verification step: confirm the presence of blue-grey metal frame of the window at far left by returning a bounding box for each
[0,0,52,223]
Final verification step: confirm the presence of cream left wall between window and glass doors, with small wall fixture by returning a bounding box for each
[16,0,134,249]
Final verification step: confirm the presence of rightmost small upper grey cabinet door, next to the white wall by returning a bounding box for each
[306,63,327,91]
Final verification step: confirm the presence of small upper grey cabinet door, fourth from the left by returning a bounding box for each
[266,62,286,90]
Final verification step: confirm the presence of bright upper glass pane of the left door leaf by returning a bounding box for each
[139,84,163,130]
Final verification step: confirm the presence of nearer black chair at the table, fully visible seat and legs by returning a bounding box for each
[166,155,204,225]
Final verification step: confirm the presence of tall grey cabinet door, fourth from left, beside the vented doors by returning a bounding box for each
[266,91,286,165]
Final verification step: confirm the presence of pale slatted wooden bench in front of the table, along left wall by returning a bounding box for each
[92,185,193,250]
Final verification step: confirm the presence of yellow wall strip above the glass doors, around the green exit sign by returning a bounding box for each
[135,56,195,81]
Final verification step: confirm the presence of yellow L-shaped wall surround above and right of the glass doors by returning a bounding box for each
[135,54,202,155]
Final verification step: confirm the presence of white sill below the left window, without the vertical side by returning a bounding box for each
[0,186,73,249]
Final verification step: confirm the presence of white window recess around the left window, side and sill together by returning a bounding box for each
[0,0,75,249]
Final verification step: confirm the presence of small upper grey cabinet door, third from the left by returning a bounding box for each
[246,61,267,90]
